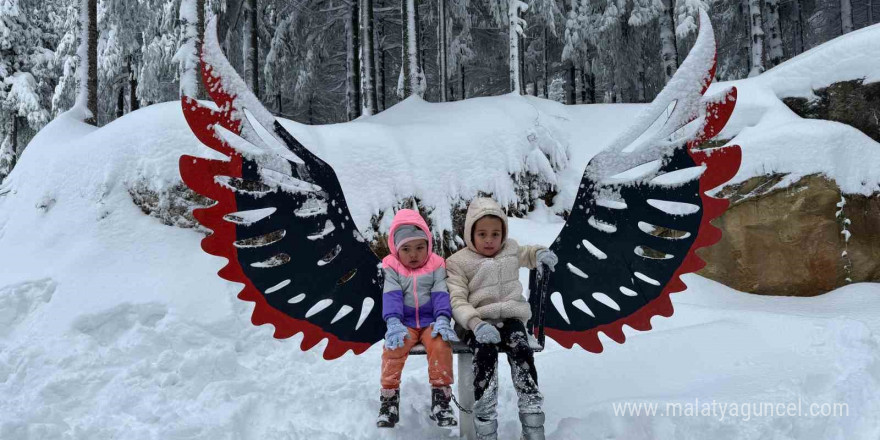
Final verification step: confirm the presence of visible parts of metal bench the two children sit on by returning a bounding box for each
[409,269,547,440]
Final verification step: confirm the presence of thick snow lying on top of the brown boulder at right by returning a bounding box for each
[707,25,880,195]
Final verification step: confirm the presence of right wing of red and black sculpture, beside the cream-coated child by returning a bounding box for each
[545,13,741,353]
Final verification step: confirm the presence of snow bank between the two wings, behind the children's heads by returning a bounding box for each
[282,95,583,235]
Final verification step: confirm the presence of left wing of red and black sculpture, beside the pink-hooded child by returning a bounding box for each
[180,18,384,359]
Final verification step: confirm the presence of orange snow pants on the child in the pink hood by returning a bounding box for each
[382,326,453,390]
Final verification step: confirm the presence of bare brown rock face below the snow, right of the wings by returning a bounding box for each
[698,175,880,296]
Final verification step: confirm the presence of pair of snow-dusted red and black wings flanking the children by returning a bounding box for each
[180,10,740,359]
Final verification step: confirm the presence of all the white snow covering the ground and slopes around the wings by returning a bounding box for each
[0,26,880,440]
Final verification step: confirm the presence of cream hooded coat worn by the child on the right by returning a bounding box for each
[446,198,546,331]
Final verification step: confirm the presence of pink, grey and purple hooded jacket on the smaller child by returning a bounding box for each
[382,209,452,328]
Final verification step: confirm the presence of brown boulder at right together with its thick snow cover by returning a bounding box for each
[700,25,880,295]
